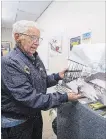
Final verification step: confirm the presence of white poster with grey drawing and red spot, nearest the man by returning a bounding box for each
[49,36,62,57]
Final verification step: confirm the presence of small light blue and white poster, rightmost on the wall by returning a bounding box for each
[81,32,91,44]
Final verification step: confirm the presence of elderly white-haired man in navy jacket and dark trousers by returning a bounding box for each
[1,20,81,139]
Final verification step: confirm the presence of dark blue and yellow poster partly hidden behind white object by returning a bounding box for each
[70,36,81,51]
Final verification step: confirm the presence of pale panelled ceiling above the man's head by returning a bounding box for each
[1,0,53,28]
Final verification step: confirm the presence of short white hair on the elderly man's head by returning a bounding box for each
[12,20,39,38]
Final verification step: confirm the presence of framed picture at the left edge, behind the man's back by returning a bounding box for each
[1,41,12,56]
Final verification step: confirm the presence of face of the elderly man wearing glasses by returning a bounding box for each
[17,27,40,55]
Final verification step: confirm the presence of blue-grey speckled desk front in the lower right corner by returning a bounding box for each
[57,99,106,139]
